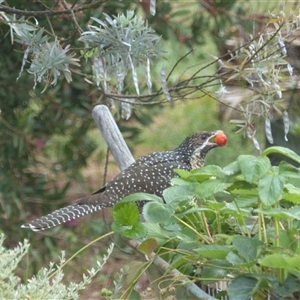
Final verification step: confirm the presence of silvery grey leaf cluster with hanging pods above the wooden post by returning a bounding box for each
[79,11,161,115]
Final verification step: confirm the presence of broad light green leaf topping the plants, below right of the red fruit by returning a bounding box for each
[238,155,271,183]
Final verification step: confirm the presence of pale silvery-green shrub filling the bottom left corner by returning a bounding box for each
[0,235,113,300]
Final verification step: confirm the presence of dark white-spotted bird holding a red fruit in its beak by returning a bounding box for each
[21,130,227,231]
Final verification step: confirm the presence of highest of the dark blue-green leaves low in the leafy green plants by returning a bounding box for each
[232,236,262,262]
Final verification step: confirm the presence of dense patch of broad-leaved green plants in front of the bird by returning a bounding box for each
[113,147,300,300]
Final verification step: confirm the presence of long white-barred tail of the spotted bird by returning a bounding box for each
[21,204,104,231]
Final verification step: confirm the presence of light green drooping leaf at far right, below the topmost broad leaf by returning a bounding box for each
[258,173,285,206]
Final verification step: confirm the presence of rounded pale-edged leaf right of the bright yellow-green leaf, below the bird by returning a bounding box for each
[143,202,175,223]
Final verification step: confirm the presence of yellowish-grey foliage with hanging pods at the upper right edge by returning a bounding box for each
[219,13,300,151]
